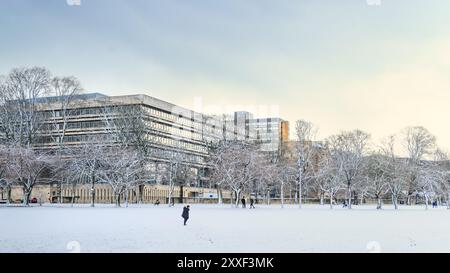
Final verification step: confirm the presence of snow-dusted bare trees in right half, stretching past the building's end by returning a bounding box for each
[211,120,450,209]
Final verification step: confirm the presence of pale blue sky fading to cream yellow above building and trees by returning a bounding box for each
[0,0,450,148]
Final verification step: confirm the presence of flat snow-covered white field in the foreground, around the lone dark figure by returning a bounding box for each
[0,204,450,252]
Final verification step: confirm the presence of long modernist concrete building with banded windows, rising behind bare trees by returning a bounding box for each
[28,93,289,186]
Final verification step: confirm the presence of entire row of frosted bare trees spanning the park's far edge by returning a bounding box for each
[0,67,450,209]
